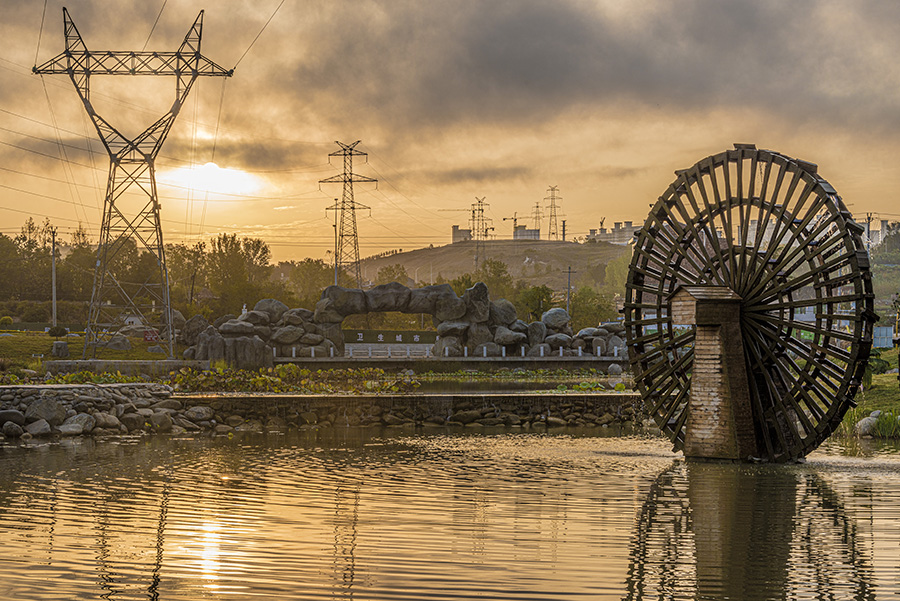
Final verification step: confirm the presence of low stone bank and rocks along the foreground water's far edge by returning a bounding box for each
[0,383,640,441]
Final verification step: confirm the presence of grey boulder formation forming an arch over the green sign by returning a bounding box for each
[181,282,626,368]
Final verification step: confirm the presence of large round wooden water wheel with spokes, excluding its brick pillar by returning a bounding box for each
[625,144,877,461]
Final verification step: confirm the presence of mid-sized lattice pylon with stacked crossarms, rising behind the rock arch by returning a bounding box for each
[319,140,378,288]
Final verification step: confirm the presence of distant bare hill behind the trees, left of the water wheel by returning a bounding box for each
[361,240,628,290]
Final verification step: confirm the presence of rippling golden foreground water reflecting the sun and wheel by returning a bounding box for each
[0,430,900,600]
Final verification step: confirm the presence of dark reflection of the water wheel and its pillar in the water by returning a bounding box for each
[624,462,875,601]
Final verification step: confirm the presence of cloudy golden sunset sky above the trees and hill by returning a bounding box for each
[0,0,900,260]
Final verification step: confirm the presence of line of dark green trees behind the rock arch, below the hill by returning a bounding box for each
[0,219,628,329]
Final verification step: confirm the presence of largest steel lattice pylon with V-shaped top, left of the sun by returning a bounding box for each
[33,8,233,357]
